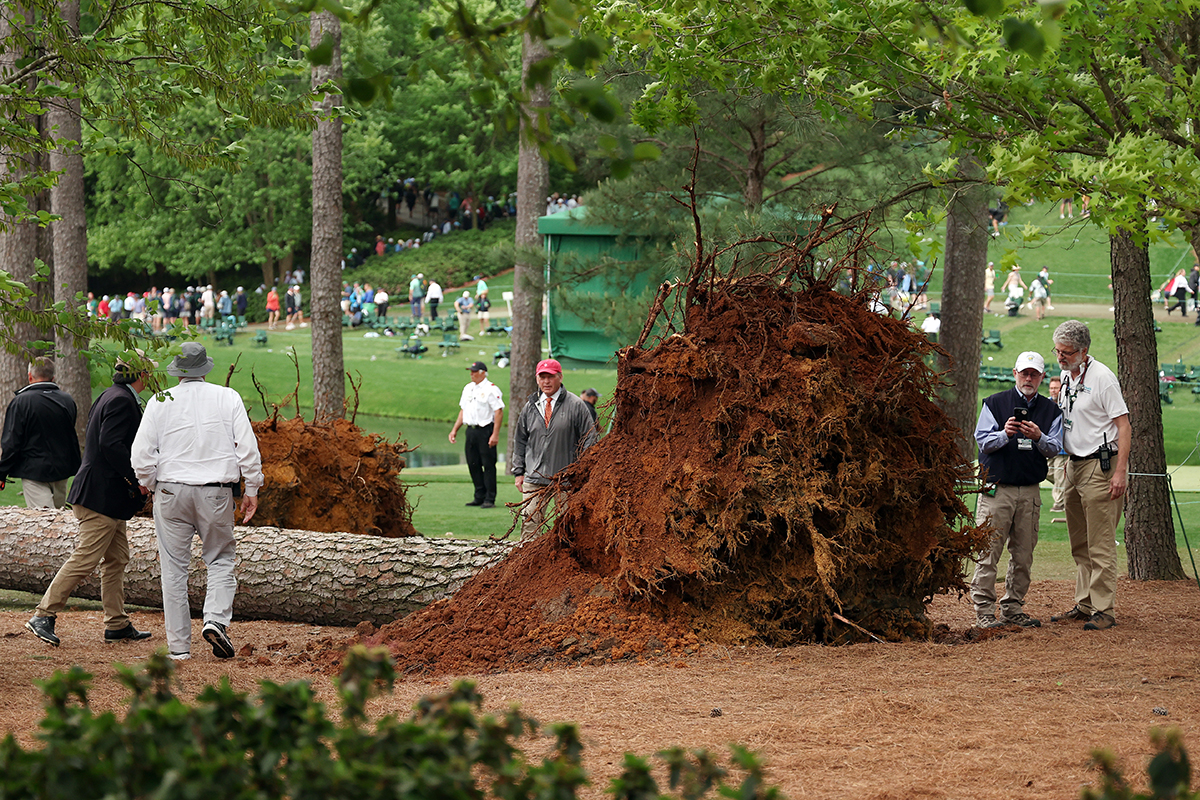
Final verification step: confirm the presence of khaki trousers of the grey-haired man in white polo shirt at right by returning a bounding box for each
[1064,456,1124,616]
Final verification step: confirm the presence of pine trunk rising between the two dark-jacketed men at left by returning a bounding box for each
[47,0,91,441]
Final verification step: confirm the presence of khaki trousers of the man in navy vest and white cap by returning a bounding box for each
[971,483,1042,615]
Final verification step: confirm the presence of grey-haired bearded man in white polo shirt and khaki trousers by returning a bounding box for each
[1050,319,1132,631]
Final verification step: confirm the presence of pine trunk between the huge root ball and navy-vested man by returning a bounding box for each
[938,154,988,459]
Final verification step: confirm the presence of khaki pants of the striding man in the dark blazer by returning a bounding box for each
[36,505,130,631]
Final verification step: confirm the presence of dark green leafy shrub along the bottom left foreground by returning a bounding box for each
[0,648,780,800]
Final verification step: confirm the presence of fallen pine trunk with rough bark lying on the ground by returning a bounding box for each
[0,507,512,625]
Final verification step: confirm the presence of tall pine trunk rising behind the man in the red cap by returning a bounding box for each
[508,0,550,452]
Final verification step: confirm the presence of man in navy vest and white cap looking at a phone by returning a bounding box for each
[971,353,1062,627]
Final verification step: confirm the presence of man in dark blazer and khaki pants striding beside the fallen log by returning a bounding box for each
[25,351,152,646]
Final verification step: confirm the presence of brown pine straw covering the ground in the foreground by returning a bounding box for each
[0,578,1200,800]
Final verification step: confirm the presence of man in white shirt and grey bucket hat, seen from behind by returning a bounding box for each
[131,342,263,661]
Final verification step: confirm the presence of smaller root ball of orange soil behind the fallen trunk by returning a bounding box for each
[253,417,420,537]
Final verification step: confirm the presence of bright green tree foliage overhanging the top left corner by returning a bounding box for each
[0,0,311,227]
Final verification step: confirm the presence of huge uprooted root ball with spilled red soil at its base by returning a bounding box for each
[370,276,986,672]
